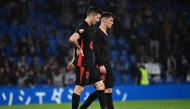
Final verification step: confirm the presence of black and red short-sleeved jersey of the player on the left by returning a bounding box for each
[75,21,94,67]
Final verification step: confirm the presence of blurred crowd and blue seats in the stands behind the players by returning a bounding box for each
[0,0,190,87]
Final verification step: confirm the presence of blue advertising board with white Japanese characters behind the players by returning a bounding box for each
[0,84,190,105]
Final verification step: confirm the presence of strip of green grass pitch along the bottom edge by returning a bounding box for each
[0,99,190,109]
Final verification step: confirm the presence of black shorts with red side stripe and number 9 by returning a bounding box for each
[75,66,101,86]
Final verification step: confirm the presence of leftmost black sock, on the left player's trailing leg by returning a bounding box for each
[72,93,80,109]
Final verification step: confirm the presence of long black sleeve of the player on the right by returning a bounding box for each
[93,31,103,66]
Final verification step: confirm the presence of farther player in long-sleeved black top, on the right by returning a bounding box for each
[80,12,114,109]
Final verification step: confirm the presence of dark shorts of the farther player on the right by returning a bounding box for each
[96,64,114,89]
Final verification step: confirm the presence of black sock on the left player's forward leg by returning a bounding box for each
[96,90,107,109]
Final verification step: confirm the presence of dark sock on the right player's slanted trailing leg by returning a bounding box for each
[80,91,97,109]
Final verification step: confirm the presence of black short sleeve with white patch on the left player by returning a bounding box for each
[75,24,88,38]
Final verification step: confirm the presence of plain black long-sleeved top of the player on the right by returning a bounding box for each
[93,28,110,66]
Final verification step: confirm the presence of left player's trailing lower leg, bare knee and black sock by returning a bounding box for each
[72,85,84,109]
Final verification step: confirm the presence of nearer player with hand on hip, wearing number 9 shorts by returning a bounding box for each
[67,7,107,109]
